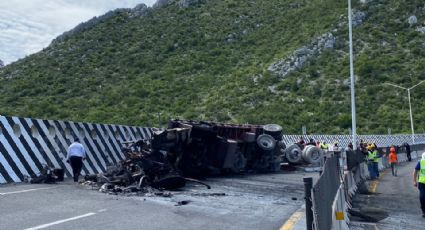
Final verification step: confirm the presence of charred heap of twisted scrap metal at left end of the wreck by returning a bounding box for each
[83,137,211,197]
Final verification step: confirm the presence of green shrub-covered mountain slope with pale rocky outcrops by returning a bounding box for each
[0,0,425,134]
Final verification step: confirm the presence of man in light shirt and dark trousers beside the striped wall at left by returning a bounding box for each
[66,138,86,182]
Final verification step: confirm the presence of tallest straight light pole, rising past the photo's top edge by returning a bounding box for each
[348,0,357,150]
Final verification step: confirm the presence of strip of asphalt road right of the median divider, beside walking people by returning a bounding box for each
[351,161,425,230]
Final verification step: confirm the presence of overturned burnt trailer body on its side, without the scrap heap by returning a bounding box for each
[157,120,285,177]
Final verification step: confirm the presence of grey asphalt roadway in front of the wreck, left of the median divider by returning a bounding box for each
[0,171,317,230]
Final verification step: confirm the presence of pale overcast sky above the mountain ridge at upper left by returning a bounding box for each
[0,0,156,64]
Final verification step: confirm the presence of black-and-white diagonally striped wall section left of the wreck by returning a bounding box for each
[0,116,152,184]
